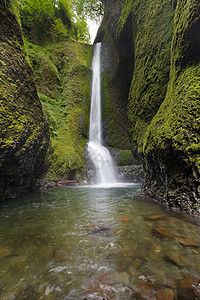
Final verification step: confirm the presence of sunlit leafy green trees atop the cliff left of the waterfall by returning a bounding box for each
[18,0,89,45]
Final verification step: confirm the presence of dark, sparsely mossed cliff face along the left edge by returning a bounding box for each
[0,1,49,200]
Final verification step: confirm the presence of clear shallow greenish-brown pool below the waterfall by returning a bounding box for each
[0,185,200,300]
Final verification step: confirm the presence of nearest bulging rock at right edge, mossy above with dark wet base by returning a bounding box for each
[144,1,200,211]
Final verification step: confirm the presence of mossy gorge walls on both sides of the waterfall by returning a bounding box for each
[0,0,200,209]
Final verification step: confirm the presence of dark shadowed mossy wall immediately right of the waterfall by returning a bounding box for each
[96,20,131,149]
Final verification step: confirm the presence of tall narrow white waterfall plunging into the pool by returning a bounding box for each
[88,43,117,184]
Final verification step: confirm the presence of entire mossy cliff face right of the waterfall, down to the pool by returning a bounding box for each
[96,0,200,211]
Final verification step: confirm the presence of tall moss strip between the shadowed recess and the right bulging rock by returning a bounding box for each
[128,1,173,153]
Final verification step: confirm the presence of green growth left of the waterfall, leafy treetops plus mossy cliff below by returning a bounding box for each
[10,0,92,179]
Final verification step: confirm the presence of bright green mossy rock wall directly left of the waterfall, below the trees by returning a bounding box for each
[26,39,92,180]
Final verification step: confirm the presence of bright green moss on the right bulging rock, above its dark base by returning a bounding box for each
[144,66,200,170]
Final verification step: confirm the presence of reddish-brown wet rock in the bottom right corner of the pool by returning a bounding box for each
[178,276,200,300]
